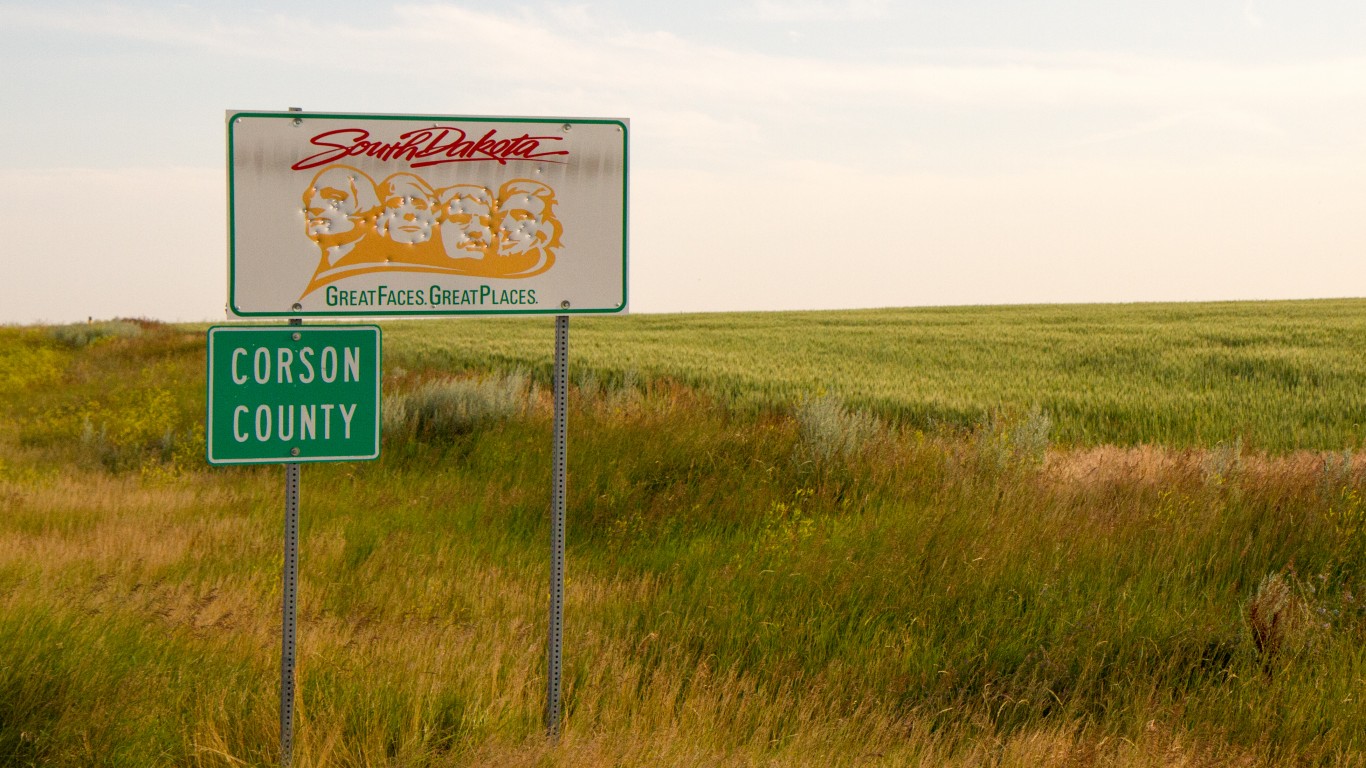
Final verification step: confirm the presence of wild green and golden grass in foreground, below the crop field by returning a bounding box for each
[0,315,1366,768]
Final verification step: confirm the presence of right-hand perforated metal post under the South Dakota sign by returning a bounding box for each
[545,314,570,741]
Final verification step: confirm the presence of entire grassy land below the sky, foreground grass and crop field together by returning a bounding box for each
[0,299,1366,768]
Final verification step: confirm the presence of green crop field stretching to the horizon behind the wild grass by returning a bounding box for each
[385,299,1366,452]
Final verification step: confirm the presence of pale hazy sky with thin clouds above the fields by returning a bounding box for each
[0,0,1366,324]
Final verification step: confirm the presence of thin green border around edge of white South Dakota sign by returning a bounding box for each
[228,111,631,317]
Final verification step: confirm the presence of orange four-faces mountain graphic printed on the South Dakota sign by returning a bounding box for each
[299,165,563,298]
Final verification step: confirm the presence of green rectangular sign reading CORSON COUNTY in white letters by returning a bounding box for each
[205,325,380,465]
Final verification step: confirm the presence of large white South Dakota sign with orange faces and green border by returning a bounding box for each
[228,112,628,317]
